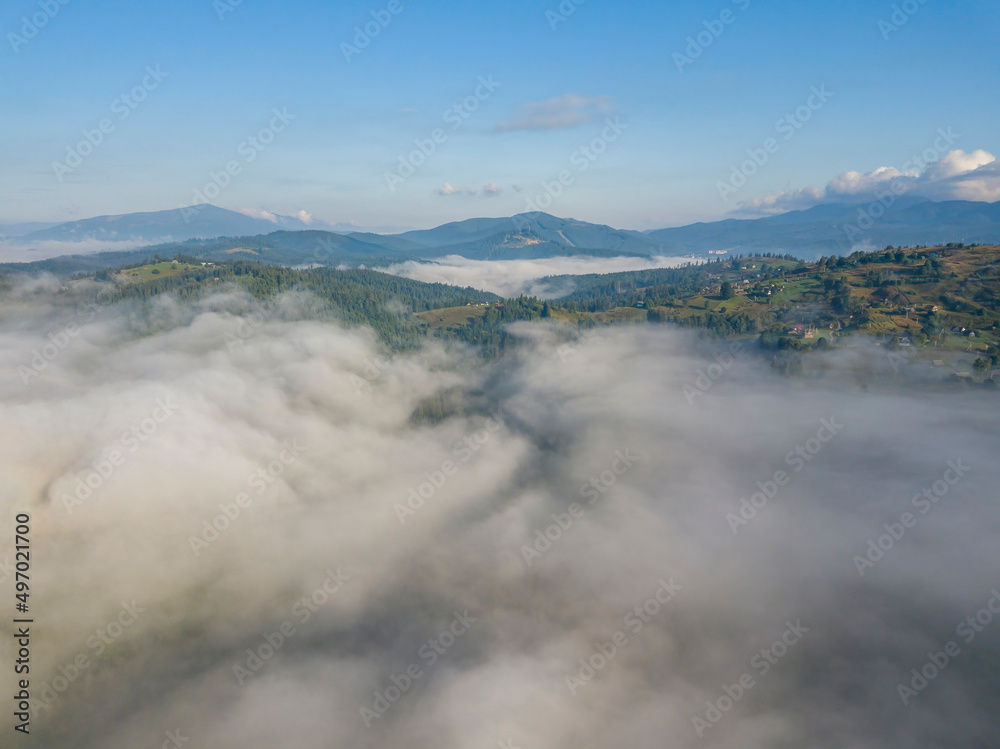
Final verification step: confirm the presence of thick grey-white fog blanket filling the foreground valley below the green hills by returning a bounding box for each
[0,279,1000,749]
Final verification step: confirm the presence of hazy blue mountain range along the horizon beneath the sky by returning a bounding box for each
[6,196,1000,265]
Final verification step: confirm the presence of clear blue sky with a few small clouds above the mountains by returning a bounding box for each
[0,0,1000,229]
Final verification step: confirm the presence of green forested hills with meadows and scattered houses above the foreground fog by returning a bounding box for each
[0,243,1000,366]
